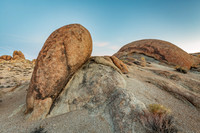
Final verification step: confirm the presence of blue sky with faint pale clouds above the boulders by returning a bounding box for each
[0,0,200,59]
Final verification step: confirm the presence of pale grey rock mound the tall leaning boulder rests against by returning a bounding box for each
[48,57,145,133]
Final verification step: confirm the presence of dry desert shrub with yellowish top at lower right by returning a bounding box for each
[140,104,178,133]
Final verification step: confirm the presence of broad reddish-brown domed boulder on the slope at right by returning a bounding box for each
[114,39,193,69]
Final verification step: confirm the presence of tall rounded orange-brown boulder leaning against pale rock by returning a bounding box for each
[26,24,92,115]
